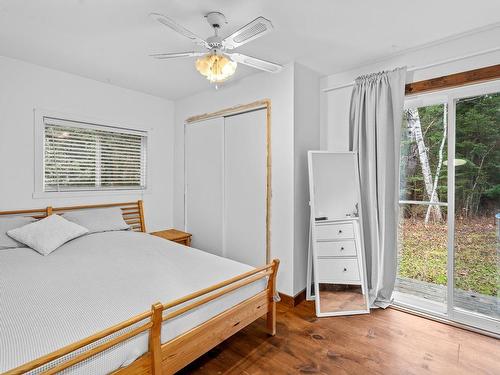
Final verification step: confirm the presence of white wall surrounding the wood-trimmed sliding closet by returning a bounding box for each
[174,64,294,295]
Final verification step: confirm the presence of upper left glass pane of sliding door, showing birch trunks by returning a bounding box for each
[400,104,447,206]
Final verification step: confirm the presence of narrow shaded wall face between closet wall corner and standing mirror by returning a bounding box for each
[293,64,320,296]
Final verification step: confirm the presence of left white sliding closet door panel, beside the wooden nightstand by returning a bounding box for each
[185,118,224,255]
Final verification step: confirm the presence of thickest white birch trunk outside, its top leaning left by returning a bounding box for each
[407,108,442,223]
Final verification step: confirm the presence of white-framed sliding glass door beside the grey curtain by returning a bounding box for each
[394,82,500,333]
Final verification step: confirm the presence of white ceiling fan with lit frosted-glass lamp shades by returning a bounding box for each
[150,12,282,84]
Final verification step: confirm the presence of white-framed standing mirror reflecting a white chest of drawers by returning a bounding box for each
[307,151,370,317]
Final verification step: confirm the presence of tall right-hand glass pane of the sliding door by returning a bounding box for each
[453,93,500,319]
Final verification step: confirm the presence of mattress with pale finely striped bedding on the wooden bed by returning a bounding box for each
[0,231,267,374]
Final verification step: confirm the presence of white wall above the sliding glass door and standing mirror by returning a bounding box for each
[321,27,500,151]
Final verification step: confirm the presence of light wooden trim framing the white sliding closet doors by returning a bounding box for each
[184,98,272,263]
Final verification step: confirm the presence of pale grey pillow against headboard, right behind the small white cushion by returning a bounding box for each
[63,207,130,233]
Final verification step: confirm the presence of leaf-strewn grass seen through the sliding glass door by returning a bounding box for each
[398,217,500,296]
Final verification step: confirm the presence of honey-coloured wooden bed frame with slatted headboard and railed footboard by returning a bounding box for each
[0,201,279,375]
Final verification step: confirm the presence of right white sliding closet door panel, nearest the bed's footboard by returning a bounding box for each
[224,109,266,266]
